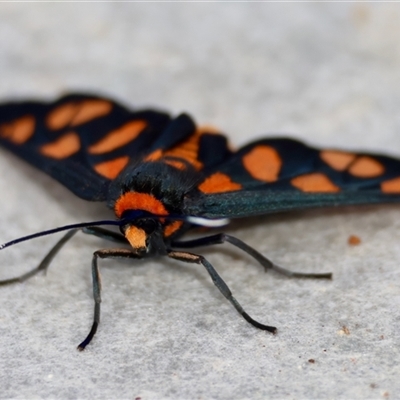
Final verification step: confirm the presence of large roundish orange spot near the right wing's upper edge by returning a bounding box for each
[243,145,282,182]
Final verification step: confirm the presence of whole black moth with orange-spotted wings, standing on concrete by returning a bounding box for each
[0,94,400,350]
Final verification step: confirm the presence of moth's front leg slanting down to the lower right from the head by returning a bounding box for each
[168,250,277,333]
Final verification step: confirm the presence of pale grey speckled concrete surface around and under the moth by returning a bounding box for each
[0,2,400,400]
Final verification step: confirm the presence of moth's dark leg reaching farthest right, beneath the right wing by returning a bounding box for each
[171,233,332,279]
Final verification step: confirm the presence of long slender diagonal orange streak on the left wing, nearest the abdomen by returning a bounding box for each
[88,121,147,154]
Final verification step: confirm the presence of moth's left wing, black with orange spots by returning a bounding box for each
[0,94,195,201]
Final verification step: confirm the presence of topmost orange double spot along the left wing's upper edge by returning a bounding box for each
[46,100,112,130]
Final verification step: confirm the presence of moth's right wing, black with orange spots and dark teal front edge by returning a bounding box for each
[185,138,400,218]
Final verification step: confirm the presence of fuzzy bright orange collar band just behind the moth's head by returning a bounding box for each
[114,192,168,218]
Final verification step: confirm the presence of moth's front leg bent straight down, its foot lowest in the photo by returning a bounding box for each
[78,249,141,351]
